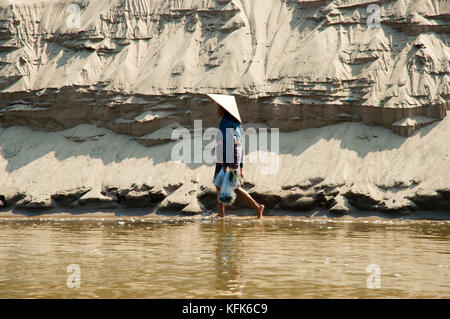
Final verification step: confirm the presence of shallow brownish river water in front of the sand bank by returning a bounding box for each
[0,216,450,298]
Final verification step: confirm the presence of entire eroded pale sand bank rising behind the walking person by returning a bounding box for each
[0,0,450,213]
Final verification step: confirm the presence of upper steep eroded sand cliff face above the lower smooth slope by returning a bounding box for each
[0,0,450,136]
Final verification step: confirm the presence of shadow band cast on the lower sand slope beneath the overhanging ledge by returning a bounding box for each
[0,116,441,173]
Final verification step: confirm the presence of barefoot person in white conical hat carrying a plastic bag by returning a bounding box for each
[208,94,264,218]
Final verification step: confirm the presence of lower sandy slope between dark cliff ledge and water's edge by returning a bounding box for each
[0,114,450,213]
